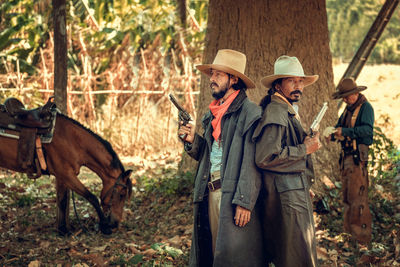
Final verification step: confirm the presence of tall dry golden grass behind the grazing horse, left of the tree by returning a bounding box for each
[0,34,200,158]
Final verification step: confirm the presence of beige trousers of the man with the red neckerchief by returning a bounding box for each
[208,172,221,253]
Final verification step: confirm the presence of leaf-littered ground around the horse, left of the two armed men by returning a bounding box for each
[0,158,192,267]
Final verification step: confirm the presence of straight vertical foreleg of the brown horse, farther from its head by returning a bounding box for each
[56,179,71,235]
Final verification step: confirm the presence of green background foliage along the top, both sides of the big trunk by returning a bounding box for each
[0,0,400,78]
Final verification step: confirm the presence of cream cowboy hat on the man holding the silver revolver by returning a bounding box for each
[261,55,319,88]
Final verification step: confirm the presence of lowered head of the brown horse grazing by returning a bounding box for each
[100,170,132,228]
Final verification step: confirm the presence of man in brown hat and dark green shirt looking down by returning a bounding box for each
[331,78,374,244]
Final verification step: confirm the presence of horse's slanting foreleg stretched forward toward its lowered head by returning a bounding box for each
[57,174,112,234]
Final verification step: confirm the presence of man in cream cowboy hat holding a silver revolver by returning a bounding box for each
[253,55,321,267]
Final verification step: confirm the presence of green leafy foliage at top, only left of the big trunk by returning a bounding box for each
[0,0,207,75]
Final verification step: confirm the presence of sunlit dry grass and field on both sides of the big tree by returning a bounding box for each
[0,57,400,161]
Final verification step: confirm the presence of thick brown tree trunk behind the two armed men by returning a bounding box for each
[183,0,339,192]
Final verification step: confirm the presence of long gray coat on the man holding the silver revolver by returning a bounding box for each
[253,96,317,267]
